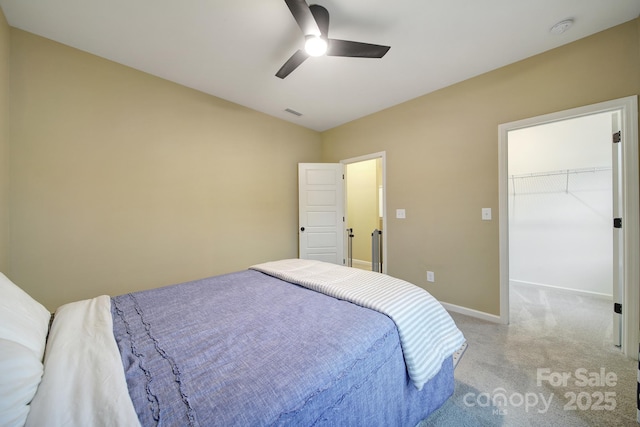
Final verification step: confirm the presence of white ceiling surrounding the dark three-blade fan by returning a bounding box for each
[0,0,640,131]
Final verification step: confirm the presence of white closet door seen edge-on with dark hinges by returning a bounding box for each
[611,112,624,347]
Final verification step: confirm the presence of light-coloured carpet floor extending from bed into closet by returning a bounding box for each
[419,285,638,427]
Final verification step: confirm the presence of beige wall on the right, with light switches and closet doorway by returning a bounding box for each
[322,19,640,315]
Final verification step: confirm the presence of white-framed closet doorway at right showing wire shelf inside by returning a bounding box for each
[499,97,639,357]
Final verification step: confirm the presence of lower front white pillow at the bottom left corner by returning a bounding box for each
[0,338,43,426]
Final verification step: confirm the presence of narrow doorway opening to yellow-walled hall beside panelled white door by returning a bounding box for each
[341,152,387,272]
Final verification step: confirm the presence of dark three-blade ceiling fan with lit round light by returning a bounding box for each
[276,0,390,79]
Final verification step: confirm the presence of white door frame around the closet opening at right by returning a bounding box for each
[498,95,640,359]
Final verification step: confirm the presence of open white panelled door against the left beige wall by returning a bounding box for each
[298,163,346,265]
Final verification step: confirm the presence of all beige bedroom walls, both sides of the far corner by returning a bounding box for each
[5,20,640,314]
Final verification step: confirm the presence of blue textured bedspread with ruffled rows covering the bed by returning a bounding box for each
[112,270,454,427]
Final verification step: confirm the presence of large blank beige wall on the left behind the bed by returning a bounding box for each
[9,29,321,309]
